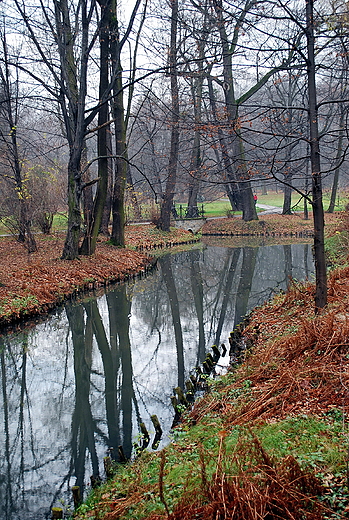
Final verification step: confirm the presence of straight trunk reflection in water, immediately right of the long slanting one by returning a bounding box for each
[190,251,205,364]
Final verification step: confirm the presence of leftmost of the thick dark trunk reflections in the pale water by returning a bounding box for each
[66,305,99,489]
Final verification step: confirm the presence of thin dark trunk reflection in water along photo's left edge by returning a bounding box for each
[0,338,13,518]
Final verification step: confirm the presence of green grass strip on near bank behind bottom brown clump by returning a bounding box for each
[72,402,347,520]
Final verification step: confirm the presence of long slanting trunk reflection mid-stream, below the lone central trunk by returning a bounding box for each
[159,255,184,388]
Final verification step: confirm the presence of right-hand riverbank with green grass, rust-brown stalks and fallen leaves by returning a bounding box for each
[67,209,349,520]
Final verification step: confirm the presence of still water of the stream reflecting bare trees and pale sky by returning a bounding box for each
[0,244,313,520]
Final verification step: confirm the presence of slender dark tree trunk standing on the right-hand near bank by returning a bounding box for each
[306,0,327,312]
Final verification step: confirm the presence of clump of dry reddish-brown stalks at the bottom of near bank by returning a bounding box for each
[147,432,326,520]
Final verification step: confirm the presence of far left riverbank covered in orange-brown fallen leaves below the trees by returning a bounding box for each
[0,225,197,326]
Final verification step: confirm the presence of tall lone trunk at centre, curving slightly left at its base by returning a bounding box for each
[158,0,179,231]
